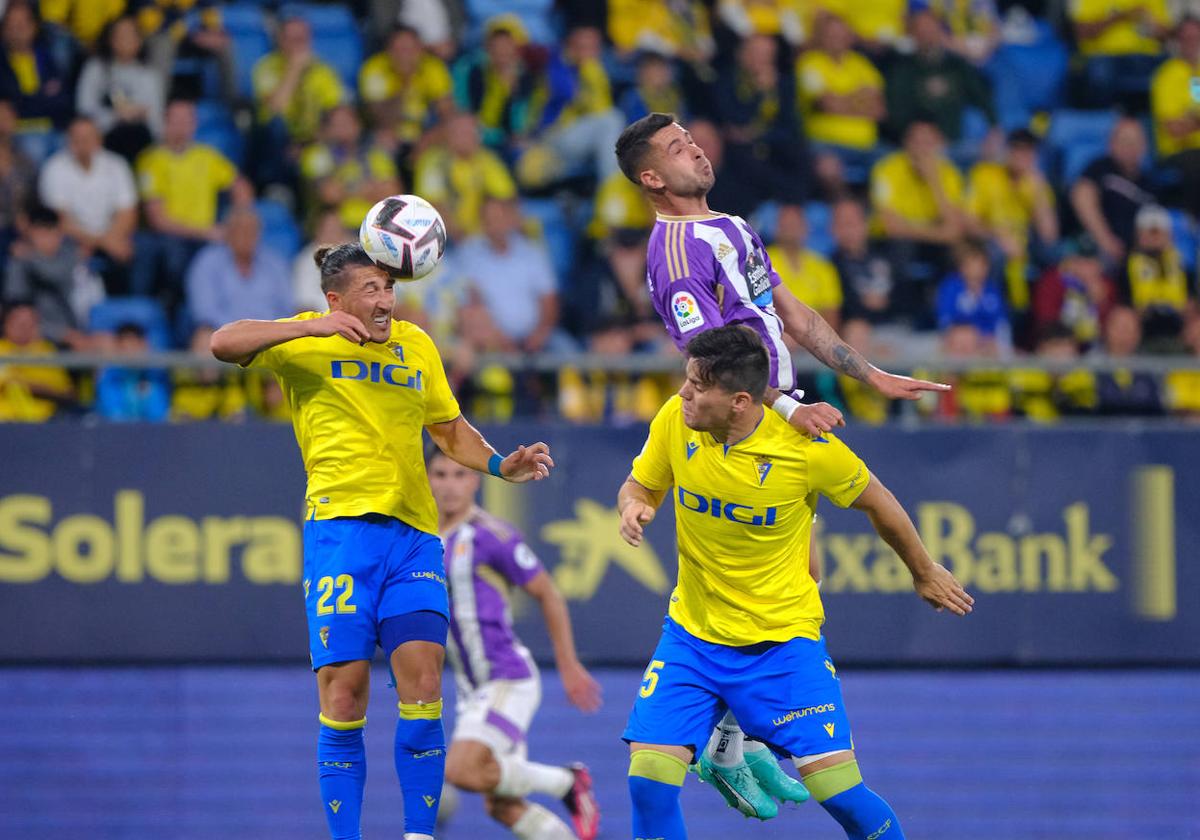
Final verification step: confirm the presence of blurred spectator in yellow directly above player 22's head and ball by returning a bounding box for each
[300,104,400,228]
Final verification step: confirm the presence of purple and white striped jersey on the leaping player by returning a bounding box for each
[646,212,796,391]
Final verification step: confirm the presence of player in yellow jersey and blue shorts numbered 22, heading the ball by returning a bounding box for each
[211,242,553,840]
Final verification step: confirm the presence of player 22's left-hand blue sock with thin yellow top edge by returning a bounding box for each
[317,715,367,840]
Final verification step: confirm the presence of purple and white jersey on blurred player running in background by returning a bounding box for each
[444,509,542,689]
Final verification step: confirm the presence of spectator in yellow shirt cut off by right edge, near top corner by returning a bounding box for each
[1150,17,1200,215]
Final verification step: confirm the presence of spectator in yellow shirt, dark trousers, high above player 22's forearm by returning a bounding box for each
[252,18,347,185]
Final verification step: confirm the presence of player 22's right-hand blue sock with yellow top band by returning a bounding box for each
[396,700,446,834]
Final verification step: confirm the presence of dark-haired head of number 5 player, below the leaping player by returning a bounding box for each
[679,325,770,437]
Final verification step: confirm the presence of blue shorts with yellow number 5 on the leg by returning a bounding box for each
[622,618,852,757]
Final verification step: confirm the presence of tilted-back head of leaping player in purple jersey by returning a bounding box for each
[617,112,716,198]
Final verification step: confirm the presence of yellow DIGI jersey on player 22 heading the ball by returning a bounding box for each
[250,312,461,534]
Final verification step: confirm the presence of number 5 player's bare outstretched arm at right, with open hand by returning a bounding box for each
[851,473,974,616]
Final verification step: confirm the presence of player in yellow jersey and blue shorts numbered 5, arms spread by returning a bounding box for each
[618,325,974,840]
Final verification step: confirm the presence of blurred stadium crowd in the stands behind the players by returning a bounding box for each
[0,0,1200,422]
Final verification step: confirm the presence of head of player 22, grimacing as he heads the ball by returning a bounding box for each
[313,242,396,343]
